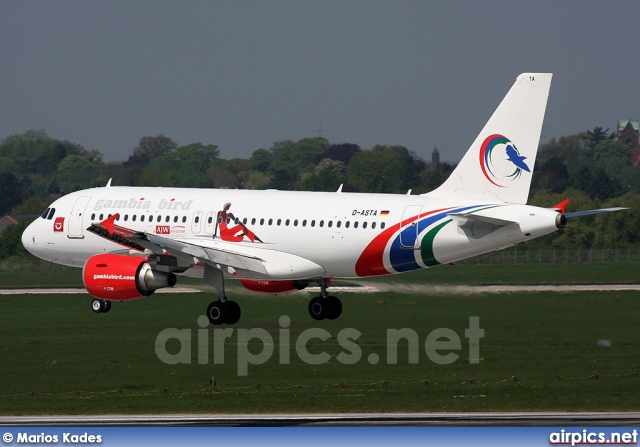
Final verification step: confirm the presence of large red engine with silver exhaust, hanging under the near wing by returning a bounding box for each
[82,254,176,301]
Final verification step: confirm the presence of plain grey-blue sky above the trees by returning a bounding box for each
[0,0,640,162]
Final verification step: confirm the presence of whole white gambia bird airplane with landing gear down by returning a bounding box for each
[22,73,621,325]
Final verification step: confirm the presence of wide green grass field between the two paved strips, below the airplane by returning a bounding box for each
[0,288,640,415]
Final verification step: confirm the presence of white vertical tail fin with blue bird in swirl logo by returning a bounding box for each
[425,73,552,204]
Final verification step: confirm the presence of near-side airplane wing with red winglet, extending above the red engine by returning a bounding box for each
[87,214,267,274]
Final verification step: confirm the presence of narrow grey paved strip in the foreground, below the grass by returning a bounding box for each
[0,412,640,427]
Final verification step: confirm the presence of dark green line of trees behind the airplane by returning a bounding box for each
[0,127,640,258]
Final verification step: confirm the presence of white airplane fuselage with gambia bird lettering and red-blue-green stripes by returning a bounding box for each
[23,187,558,279]
